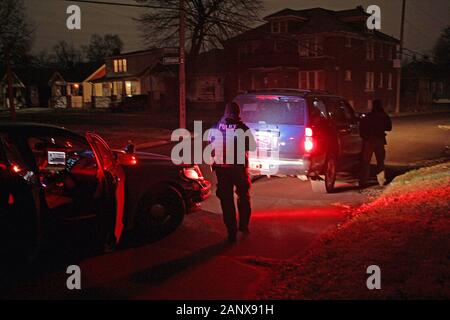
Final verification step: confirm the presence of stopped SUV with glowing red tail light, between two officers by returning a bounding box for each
[234,89,362,193]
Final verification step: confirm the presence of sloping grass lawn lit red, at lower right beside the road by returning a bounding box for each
[259,163,450,299]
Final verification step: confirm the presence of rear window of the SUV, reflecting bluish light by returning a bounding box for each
[236,95,306,125]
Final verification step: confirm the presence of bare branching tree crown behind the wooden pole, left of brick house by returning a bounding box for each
[135,0,263,57]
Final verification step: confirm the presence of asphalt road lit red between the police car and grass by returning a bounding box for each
[4,114,450,299]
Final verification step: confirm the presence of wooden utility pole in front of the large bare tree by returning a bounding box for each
[178,0,186,128]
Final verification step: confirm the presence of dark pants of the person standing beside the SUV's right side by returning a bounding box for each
[360,139,386,186]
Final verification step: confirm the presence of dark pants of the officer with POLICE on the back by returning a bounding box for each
[215,166,251,234]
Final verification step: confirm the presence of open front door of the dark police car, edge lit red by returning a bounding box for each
[86,132,125,244]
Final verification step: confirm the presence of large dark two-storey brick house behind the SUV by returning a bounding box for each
[225,7,399,111]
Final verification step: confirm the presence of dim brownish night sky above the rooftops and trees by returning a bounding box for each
[25,0,450,54]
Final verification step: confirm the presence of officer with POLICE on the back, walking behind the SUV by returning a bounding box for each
[211,102,256,242]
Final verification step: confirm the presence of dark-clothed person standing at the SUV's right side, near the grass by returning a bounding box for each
[360,100,392,187]
